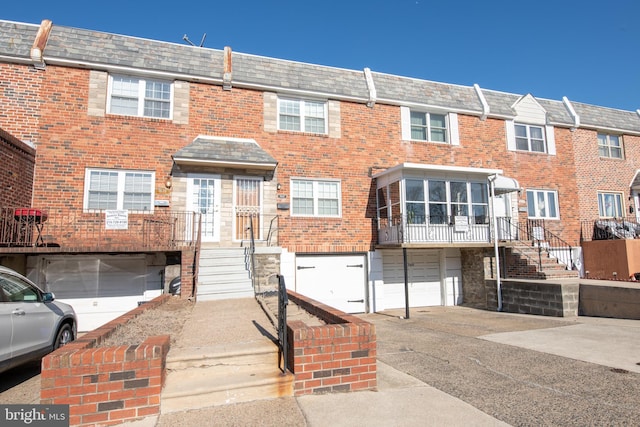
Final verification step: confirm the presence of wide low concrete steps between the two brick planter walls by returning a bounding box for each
[160,341,294,413]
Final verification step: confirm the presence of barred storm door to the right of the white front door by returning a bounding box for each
[234,178,262,240]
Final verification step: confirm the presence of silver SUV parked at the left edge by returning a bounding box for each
[0,266,78,372]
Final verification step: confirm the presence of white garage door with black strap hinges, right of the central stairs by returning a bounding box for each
[296,255,367,313]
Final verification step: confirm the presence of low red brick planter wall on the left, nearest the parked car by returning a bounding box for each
[40,294,171,426]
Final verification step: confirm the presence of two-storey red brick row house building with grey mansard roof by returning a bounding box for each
[0,20,640,329]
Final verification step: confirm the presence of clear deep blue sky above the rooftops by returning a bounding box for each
[0,0,640,111]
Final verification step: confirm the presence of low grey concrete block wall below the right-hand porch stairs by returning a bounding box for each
[486,280,579,317]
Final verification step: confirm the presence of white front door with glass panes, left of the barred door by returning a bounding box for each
[187,175,220,242]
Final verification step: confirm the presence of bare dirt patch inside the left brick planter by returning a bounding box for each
[100,297,193,347]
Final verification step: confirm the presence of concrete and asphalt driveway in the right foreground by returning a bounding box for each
[362,307,640,426]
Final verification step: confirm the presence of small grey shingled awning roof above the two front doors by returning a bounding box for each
[173,136,278,168]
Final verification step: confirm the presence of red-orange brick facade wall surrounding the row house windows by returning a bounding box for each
[0,65,578,252]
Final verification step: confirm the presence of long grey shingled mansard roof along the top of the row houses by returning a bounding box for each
[0,21,640,133]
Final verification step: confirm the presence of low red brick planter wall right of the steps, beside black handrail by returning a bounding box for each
[287,291,377,396]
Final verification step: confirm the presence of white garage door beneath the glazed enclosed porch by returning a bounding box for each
[382,250,442,308]
